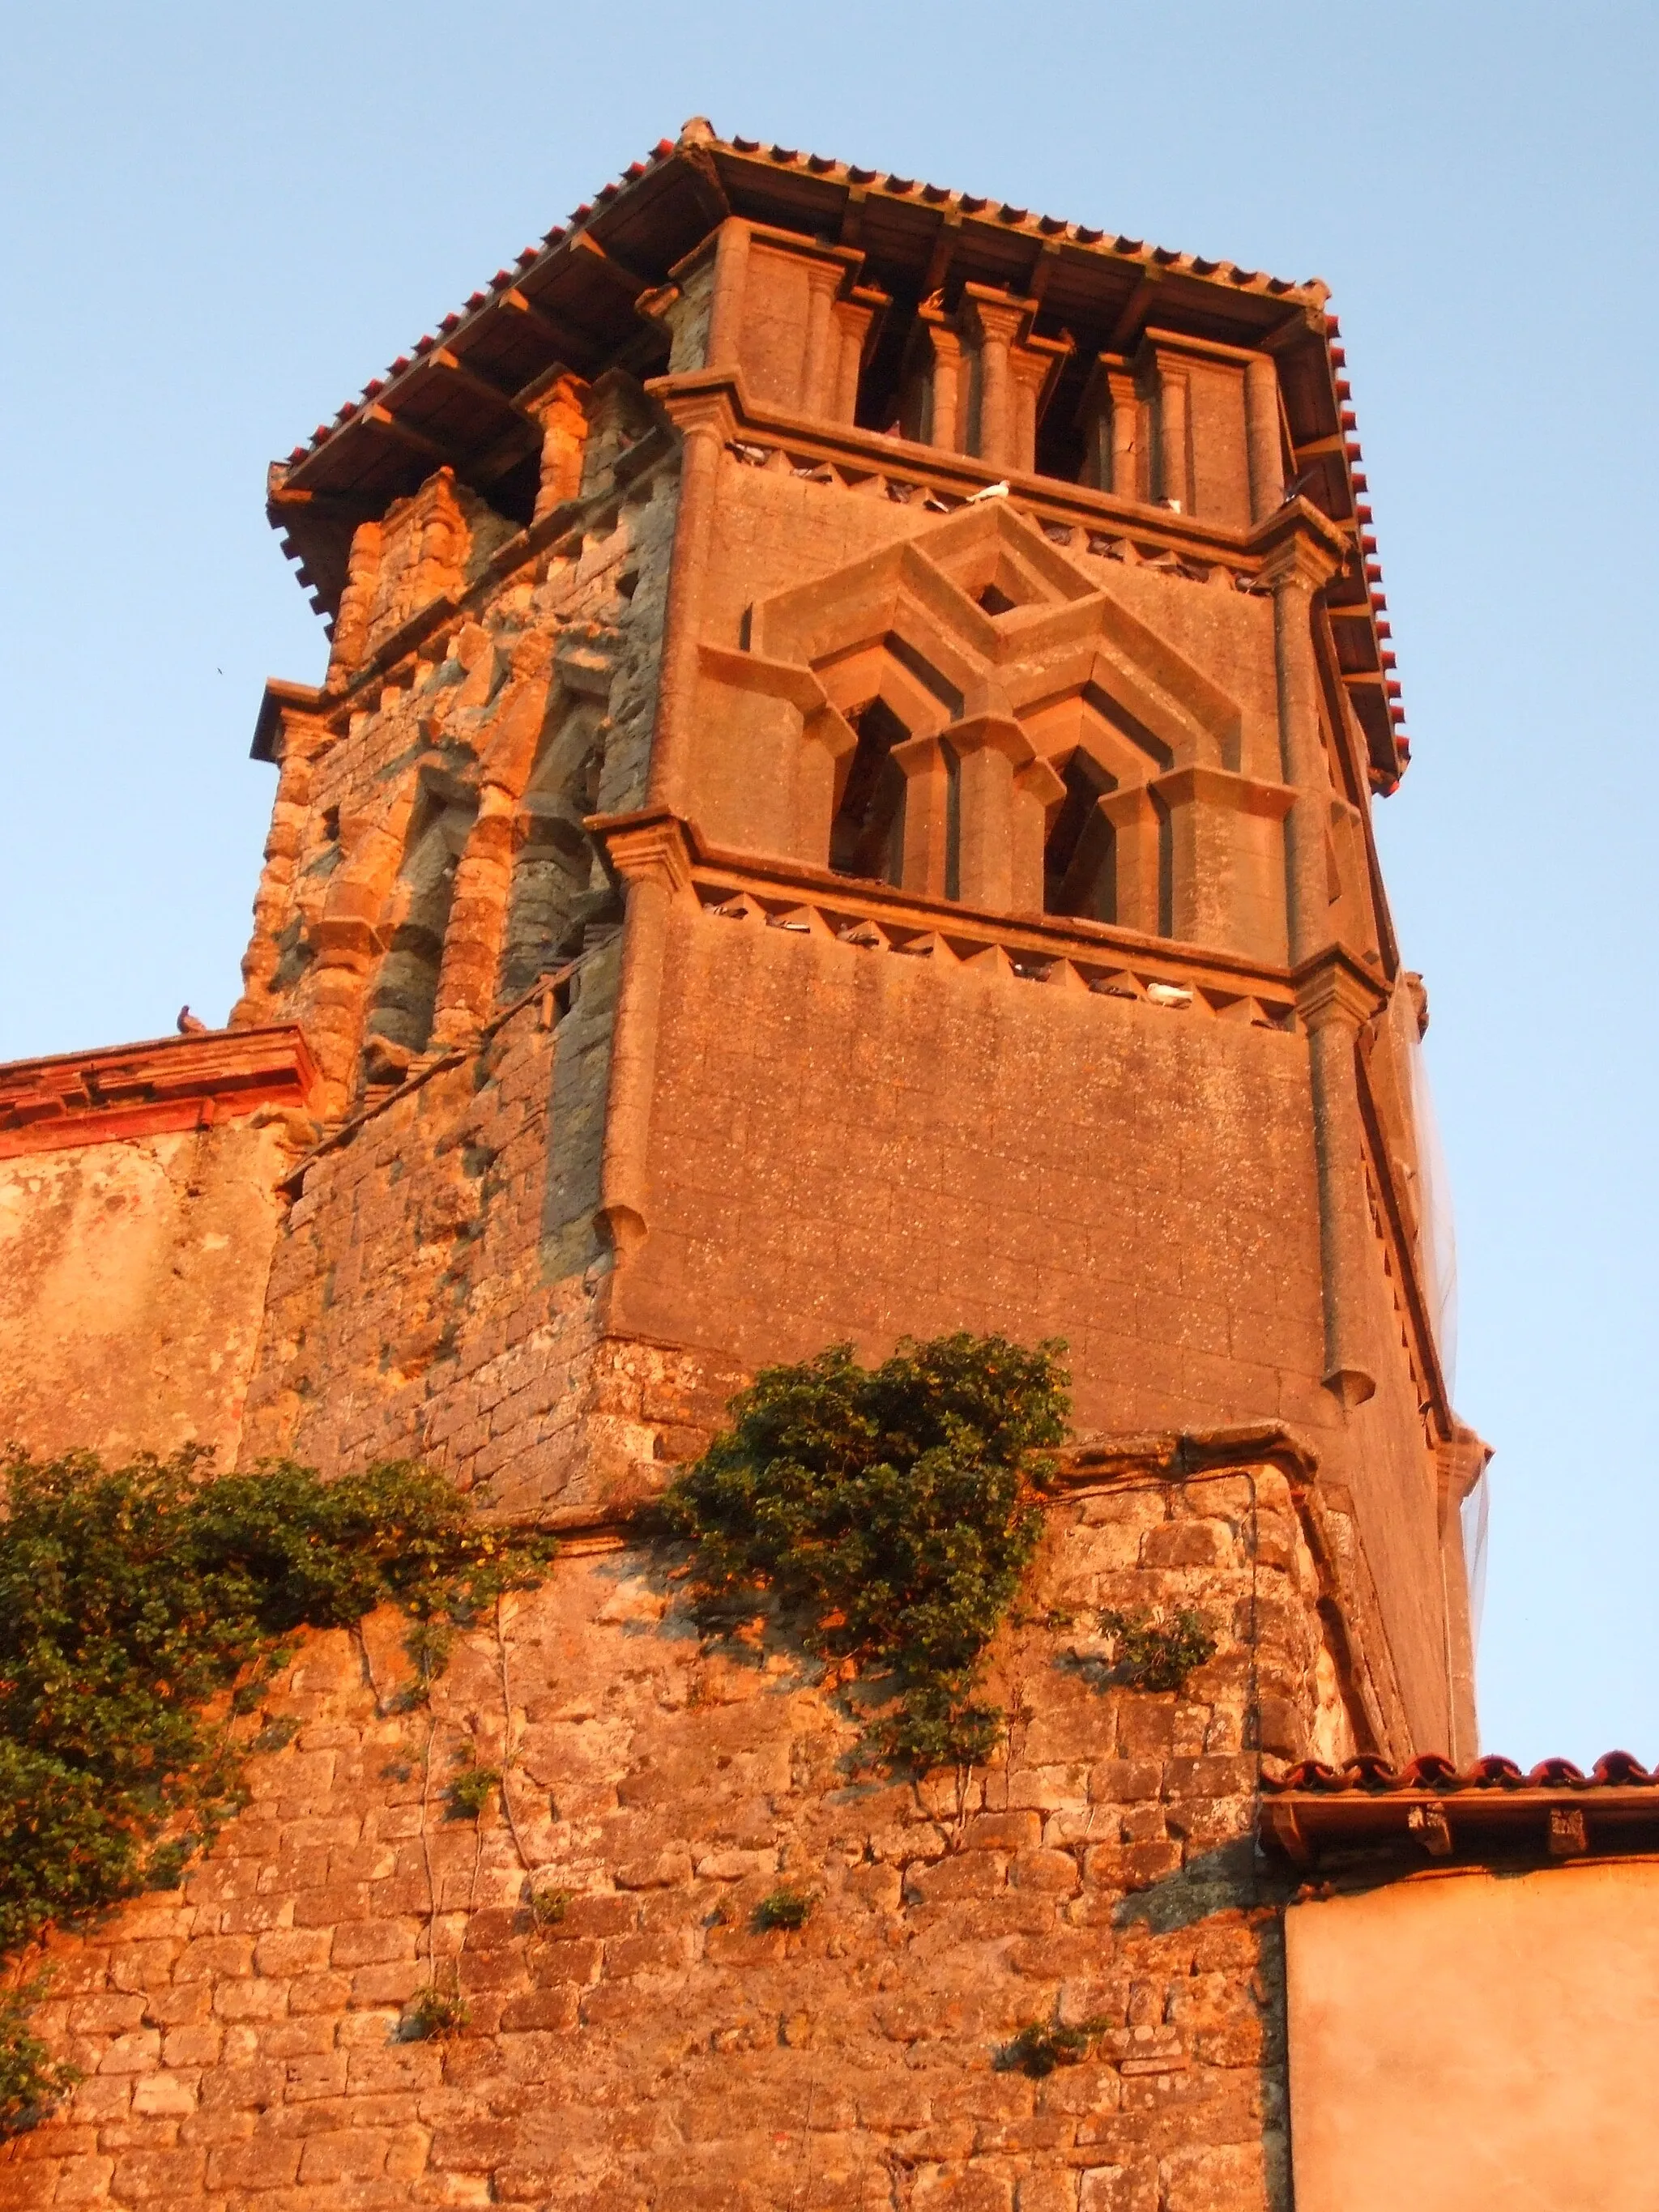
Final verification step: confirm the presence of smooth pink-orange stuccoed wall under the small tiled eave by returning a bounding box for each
[1286,1860,1659,2212]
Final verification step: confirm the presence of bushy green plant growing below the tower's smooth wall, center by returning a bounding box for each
[666,1332,1071,1770]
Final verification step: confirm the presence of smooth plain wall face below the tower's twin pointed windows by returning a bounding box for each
[620,901,1341,1434]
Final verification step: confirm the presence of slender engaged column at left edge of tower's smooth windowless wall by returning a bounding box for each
[588,814,690,1261]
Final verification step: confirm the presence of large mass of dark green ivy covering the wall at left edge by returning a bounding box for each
[0,1451,551,2133]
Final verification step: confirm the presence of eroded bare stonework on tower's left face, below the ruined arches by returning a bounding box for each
[243,938,736,1519]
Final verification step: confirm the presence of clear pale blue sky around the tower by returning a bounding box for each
[0,0,1659,1761]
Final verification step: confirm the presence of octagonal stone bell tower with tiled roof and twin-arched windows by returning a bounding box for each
[234,124,1484,1756]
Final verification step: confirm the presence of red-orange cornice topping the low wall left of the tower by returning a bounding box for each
[0,1022,316,1159]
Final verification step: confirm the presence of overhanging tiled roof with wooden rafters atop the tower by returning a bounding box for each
[267,121,1407,765]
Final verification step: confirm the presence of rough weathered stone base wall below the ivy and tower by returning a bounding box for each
[0,1464,1350,2212]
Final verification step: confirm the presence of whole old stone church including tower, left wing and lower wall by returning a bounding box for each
[0,121,1484,2212]
